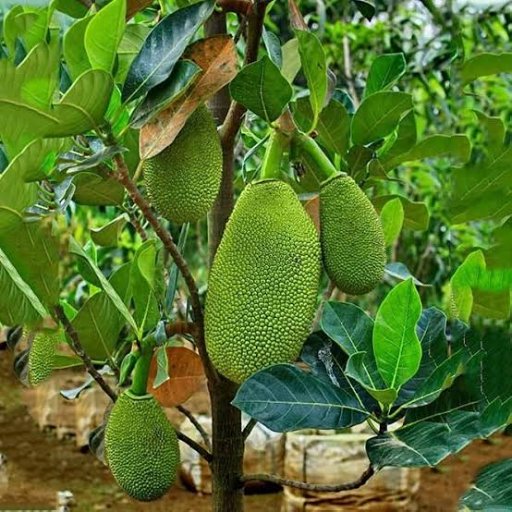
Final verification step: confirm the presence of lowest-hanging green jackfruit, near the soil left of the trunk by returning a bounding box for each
[105,390,180,501]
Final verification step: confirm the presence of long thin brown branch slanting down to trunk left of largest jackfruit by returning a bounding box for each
[109,152,218,380]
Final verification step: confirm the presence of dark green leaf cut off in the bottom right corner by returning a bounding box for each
[459,458,512,512]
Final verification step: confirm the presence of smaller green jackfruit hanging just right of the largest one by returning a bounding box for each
[320,176,386,295]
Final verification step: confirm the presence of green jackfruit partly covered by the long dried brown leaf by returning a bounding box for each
[144,106,222,224]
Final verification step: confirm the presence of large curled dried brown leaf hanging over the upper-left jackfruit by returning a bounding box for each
[140,35,237,159]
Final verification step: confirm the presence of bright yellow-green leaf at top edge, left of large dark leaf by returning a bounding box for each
[84,0,126,72]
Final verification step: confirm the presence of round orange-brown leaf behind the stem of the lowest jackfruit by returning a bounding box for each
[148,347,205,407]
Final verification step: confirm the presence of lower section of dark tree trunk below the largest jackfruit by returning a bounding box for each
[210,380,244,512]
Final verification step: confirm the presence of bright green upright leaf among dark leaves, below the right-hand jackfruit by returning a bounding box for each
[373,279,421,389]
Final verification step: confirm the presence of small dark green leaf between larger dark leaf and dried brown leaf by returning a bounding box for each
[131,60,202,128]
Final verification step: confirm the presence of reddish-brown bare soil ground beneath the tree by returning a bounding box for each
[0,352,512,512]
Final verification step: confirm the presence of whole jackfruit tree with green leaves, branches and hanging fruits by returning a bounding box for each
[0,0,512,512]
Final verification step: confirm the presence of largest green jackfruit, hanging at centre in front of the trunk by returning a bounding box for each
[205,180,321,383]
